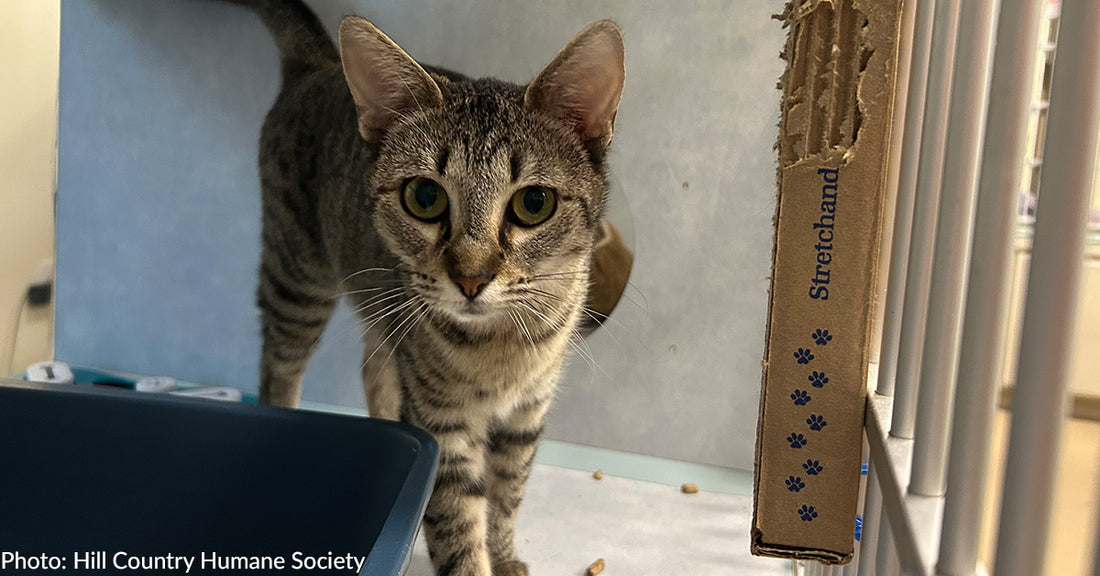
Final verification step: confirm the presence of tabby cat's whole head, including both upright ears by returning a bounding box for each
[340,19,624,331]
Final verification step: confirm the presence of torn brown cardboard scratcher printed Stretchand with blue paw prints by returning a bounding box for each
[752,0,901,564]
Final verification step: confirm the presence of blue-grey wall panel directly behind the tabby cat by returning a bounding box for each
[56,0,783,468]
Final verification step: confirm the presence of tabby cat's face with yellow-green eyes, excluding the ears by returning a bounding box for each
[370,79,607,325]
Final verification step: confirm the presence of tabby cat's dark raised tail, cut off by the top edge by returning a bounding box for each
[228,0,340,79]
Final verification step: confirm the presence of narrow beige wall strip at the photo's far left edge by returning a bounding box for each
[0,0,59,374]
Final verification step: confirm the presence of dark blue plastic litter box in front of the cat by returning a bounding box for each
[0,380,439,576]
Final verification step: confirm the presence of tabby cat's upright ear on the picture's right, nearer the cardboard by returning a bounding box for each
[524,20,626,147]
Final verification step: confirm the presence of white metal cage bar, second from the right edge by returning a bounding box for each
[937,0,1043,576]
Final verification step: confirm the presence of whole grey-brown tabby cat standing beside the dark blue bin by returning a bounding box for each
[229,0,625,576]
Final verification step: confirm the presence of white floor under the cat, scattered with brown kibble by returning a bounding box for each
[408,464,791,576]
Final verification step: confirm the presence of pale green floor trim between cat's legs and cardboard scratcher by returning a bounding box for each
[535,440,752,496]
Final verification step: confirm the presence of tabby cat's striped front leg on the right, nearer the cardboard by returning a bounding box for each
[488,398,550,576]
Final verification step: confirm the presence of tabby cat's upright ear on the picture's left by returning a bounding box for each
[340,16,443,142]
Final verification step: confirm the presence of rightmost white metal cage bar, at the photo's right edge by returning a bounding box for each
[994,0,1100,576]
